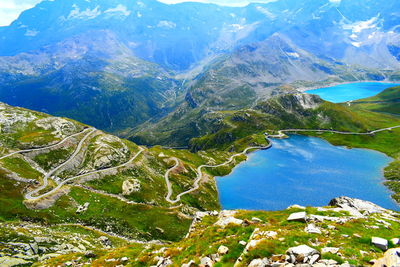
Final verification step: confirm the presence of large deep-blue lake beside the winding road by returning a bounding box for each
[217,135,399,210]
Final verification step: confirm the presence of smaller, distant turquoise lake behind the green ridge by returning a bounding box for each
[307,82,399,103]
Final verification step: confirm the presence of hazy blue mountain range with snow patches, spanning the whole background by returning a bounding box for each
[0,0,400,144]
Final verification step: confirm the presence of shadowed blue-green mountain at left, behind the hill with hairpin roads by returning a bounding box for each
[0,31,180,131]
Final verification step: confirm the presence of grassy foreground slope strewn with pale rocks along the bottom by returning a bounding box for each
[0,197,400,267]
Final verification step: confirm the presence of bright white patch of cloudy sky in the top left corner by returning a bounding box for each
[0,0,41,26]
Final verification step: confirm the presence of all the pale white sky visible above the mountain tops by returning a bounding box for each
[0,0,274,26]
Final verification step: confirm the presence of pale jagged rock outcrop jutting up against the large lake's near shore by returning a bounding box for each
[329,197,388,217]
